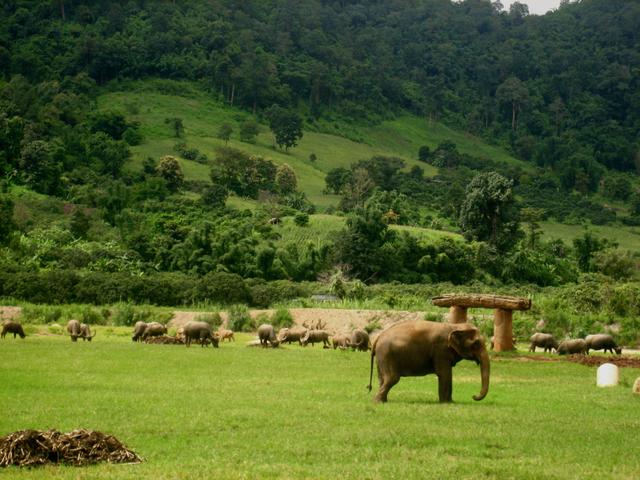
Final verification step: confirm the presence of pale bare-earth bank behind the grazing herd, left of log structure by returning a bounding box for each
[169,308,424,334]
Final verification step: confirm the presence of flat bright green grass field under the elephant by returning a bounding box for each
[0,327,640,479]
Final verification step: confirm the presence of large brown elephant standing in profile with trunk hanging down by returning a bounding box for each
[368,320,490,402]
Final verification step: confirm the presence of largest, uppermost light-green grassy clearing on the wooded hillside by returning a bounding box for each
[98,82,526,208]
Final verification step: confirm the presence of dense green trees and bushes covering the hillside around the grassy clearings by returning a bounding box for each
[0,0,640,305]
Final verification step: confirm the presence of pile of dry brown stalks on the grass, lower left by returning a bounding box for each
[0,429,142,467]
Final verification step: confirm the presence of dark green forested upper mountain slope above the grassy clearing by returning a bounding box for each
[0,0,640,175]
